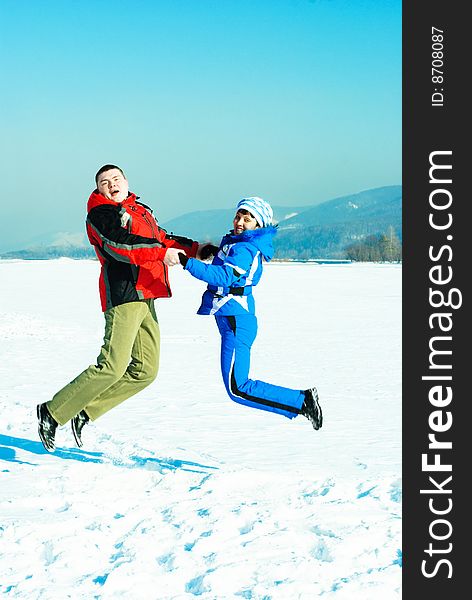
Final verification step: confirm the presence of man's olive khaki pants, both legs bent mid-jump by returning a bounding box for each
[47,300,160,425]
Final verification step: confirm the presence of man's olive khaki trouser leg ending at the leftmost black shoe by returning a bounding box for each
[46,302,153,425]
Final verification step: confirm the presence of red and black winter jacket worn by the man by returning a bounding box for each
[87,190,198,311]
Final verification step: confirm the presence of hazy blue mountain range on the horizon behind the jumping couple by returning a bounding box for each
[0,185,402,260]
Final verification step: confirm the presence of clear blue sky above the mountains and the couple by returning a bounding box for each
[0,0,401,250]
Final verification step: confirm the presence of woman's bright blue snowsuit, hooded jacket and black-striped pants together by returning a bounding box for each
[185,226,305,419]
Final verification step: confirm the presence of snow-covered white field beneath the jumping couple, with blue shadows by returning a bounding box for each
[0,259,402,600]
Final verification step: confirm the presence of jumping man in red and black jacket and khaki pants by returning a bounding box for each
[37,165,199,452]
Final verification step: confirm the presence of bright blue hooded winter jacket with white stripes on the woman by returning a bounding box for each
[185,226,277,316]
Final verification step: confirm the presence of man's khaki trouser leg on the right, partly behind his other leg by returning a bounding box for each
[85,300,160,421]
